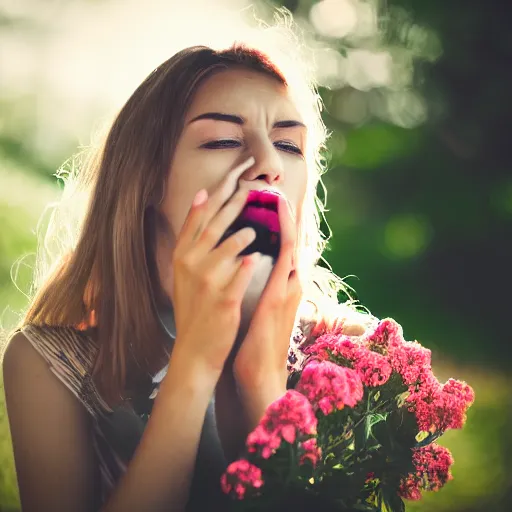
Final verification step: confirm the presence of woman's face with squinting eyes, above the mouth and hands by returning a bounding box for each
[158,69,307,300]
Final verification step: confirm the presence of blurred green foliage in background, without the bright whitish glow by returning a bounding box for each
[0,0,512,512]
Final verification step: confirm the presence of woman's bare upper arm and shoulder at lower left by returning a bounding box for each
[2,332,100,512]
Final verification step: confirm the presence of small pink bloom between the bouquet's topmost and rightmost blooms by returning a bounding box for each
[390,341,431,386]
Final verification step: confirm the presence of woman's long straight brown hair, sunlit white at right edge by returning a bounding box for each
[15,44,372,403]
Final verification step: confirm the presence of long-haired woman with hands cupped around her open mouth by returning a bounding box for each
[3,39,371,512]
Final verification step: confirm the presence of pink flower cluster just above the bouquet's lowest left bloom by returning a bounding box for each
[246,390,317,459]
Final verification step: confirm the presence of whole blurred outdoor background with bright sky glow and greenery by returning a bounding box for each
[0,0,512,512]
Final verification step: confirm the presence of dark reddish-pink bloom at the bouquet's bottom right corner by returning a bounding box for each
[399,443,453,500]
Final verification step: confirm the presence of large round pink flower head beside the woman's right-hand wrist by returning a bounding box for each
[296,361,363,414]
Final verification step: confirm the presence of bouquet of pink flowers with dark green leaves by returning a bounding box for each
[221,319,474,512]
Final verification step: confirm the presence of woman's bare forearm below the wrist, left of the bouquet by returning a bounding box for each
[102,348,216,512]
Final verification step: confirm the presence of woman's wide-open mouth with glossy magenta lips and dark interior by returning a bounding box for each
[215,190,281,260]
